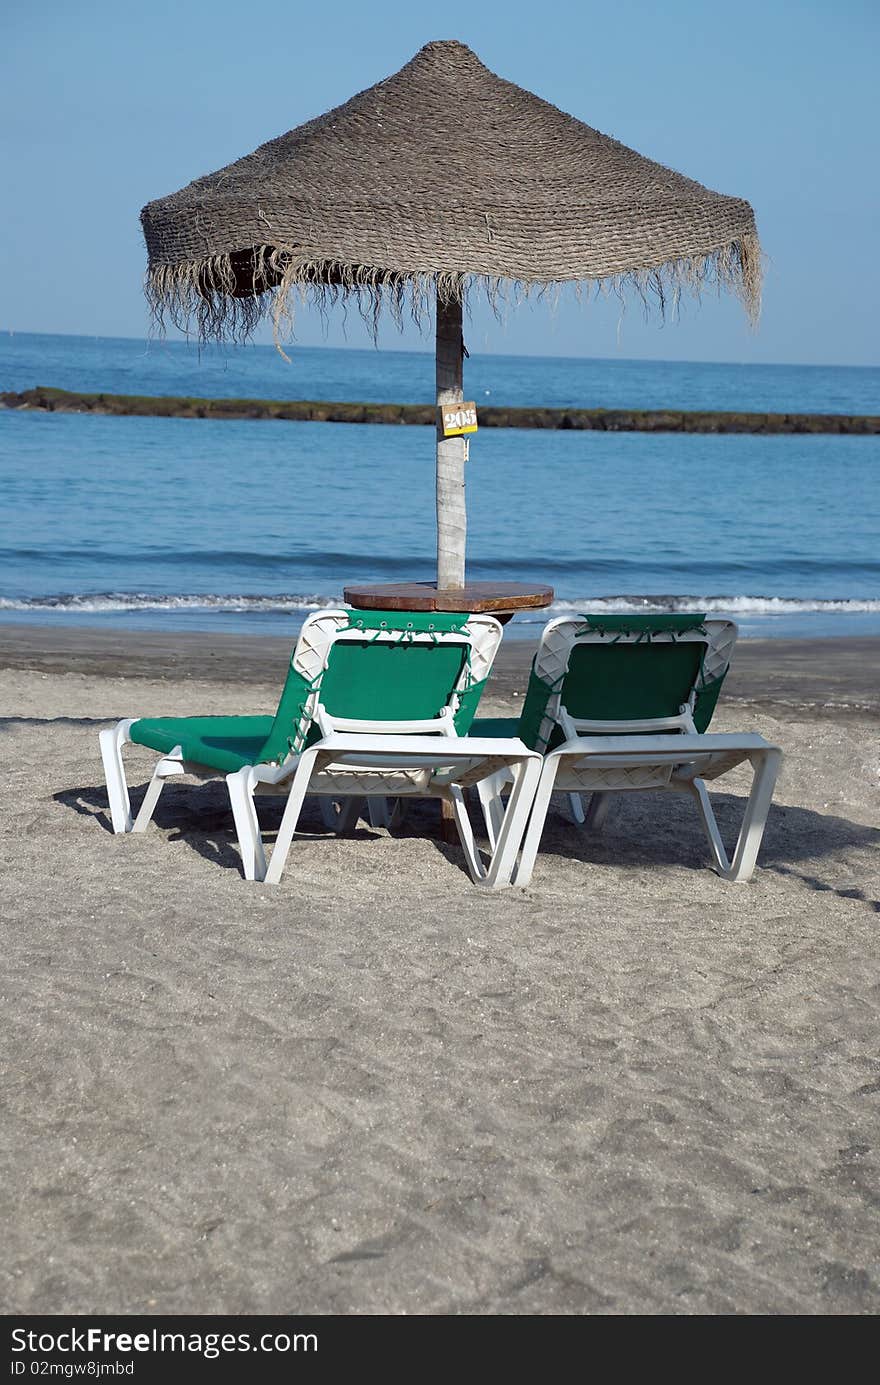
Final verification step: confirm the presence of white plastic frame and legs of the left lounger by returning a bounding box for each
[100,611,540,888]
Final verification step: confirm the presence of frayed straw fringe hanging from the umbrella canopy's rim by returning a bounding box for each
[144,233,762,360]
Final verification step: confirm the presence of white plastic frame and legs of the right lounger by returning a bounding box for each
[478,616,782,885]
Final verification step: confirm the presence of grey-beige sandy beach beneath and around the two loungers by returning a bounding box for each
[0,625,880,1314]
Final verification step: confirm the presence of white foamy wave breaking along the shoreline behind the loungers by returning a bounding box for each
[0,591,880,623]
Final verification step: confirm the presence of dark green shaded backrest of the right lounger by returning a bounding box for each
[520,615,736,751]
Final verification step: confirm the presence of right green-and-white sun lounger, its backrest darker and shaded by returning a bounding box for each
[473,615,782,885]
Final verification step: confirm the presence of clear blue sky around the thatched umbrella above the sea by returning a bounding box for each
[0,0,880,364]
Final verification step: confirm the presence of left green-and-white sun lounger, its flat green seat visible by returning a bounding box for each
[100,609,540,886]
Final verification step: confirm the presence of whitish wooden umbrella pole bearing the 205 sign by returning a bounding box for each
[437,295,467,590]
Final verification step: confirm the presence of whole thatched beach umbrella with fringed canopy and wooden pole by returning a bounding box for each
[141,43,761,589]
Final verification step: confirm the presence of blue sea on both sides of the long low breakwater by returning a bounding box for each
[0,334,880,637]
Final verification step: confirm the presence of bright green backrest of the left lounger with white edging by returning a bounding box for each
[261,609,502,763]
